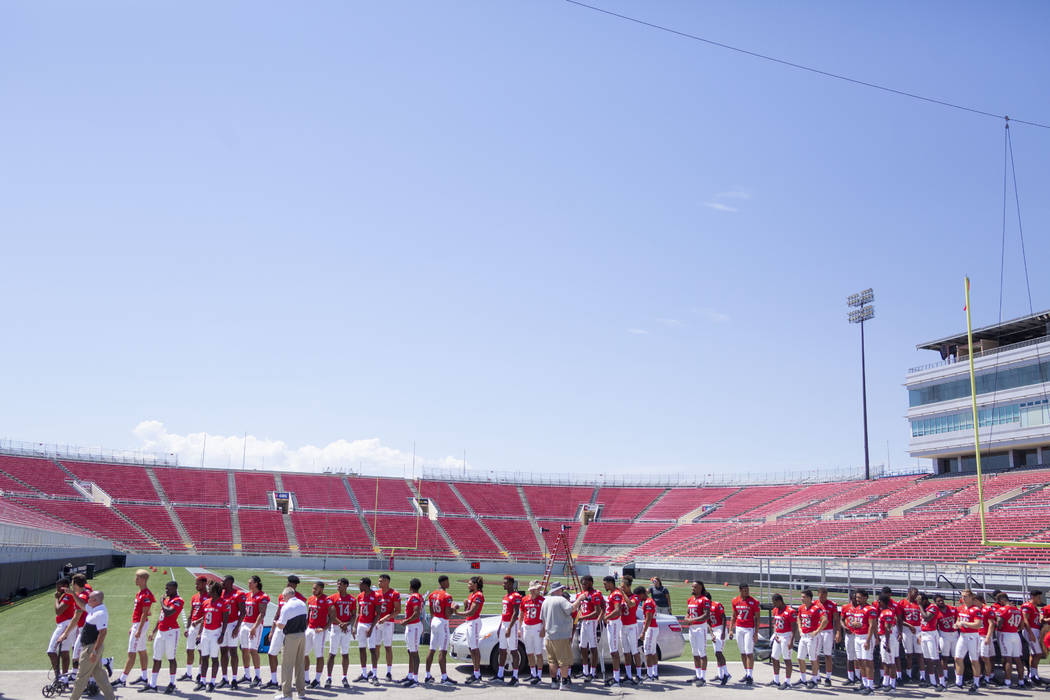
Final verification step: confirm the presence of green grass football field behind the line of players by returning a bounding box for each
[0,567,794,671]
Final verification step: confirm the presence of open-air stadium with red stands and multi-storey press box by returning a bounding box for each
[6,312,1050,695]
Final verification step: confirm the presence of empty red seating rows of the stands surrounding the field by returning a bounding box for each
[6,447,1050,564]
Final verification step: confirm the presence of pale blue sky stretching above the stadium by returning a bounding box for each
[0,0,1050,474]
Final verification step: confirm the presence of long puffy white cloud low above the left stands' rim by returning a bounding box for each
[133,421,463,473]
